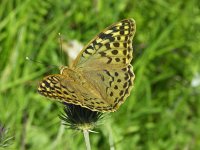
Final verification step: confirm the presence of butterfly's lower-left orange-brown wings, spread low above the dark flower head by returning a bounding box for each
[38,74,115,112]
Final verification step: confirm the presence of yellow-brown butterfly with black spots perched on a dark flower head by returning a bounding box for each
[38,19,136,112]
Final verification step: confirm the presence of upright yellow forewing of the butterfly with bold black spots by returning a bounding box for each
[73,19,136,69]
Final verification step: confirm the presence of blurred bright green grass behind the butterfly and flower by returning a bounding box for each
[0,0,200,150]
